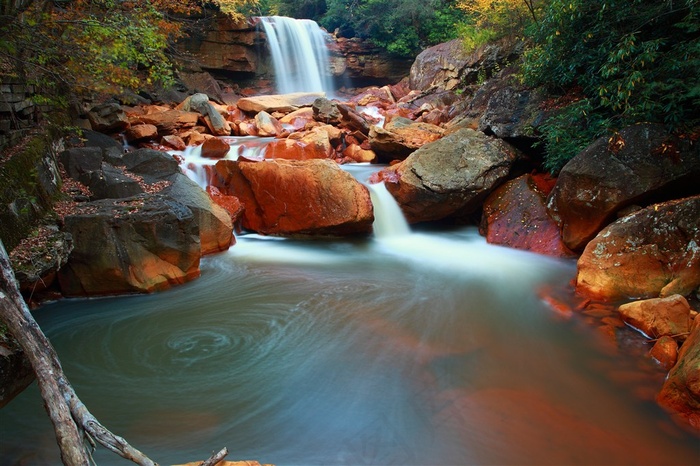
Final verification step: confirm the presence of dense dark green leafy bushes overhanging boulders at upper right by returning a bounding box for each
[523,0,700,173]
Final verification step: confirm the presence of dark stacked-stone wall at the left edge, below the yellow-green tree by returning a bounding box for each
[0,76,38,152]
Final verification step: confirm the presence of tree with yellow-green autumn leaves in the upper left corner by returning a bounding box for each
[0,0,255,104]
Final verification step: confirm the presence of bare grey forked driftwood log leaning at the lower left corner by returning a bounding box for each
[0,241,227,466]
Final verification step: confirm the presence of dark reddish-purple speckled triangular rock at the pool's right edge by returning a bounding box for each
[481,175,573,257]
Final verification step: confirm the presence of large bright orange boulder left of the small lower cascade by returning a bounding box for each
[212,160,374,236]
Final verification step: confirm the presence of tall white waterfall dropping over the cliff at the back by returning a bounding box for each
[260,16,333,94]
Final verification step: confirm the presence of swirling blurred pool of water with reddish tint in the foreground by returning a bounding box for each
[0,229,700,465]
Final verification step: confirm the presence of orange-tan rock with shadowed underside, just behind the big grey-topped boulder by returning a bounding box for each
[369,117,445,159]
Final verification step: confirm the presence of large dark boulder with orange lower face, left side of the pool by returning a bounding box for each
[58,194,200,296]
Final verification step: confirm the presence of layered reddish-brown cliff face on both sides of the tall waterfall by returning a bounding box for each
[179,18,413,87]
